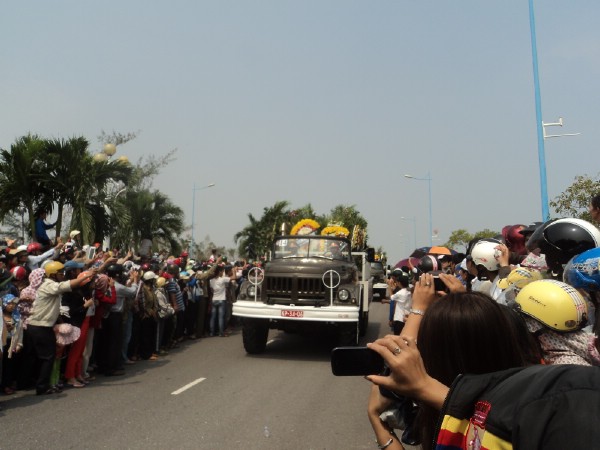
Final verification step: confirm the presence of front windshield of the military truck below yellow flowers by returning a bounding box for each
[273,236,351,261]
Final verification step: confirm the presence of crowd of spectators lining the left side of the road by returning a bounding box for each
[0,221,248,395]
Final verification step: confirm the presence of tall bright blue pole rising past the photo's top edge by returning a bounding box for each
[529,0,550,222]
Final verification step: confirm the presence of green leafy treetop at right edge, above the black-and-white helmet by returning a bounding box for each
[550,175,600,221]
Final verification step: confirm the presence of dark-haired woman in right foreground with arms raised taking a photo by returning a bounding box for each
[367,273,539,449]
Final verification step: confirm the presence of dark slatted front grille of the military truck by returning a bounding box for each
[262,277,330,305]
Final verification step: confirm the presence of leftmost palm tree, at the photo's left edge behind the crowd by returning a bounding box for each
[0,134,53,236]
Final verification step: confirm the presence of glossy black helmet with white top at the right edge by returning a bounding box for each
[527,218,600,273]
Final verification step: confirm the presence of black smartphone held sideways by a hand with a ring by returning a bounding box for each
[331,347,384,376]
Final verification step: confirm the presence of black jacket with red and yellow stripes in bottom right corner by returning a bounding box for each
[436,365,600,450]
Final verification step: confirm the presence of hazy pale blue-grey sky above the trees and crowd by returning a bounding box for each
[0,0,600,262]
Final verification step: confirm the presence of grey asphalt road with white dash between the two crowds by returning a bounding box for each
[0,303,396,449]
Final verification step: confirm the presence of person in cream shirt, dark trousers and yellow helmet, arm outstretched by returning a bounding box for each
[25,261,95,395]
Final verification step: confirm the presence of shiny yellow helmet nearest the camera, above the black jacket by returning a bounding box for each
[515,280,588,331]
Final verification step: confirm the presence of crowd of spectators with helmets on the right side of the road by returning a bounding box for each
[367,195,600,450]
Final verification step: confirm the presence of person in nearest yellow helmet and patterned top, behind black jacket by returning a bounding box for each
[515,279,600,366]
